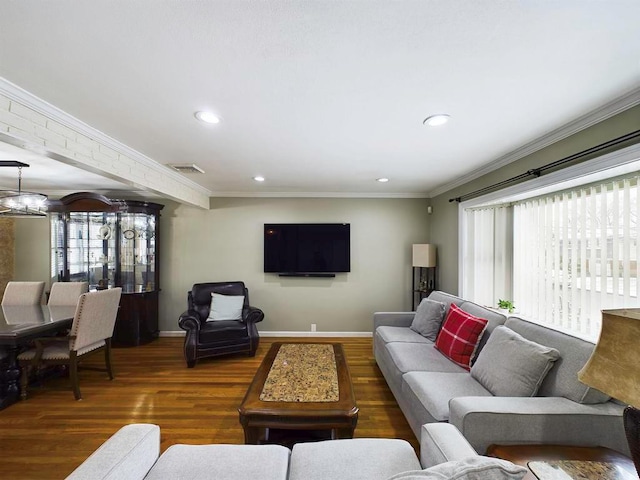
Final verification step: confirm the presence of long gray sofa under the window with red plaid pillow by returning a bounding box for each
[373,291,629,455]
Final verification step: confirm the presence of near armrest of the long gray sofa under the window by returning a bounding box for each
[449,397,629,455]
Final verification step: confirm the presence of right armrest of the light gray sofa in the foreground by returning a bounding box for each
[420,423,477,468]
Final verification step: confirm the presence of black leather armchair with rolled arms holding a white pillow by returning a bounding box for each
[178,282,264,368]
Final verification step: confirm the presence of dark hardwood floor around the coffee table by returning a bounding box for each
[0,338,419,480]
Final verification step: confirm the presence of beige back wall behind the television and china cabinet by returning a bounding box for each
[15,198,429,332]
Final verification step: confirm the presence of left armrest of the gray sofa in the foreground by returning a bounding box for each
[67,423,160,480]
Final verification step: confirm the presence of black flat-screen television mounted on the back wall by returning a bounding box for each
[264,223,351,277]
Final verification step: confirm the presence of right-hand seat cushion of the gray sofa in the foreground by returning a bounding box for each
[288,438,420,480]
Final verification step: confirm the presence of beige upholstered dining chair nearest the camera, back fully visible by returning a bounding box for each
[18,287,122,400]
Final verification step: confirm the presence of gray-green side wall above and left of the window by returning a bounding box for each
[429,106,640,294]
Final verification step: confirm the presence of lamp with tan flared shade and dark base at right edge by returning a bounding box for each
[578,308,640,475]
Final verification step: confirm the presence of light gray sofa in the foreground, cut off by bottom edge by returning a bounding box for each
[67,424,526,480]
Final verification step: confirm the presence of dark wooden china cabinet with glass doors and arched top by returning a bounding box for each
[48,192,164,346]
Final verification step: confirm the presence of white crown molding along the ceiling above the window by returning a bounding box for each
[428,87,640,198]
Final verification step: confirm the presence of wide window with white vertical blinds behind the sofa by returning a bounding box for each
[460,142,640,341]
